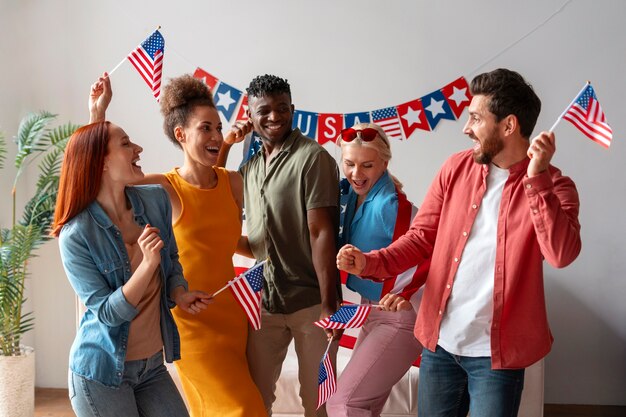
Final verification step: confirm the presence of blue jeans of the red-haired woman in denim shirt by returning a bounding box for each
[68,352,189,417]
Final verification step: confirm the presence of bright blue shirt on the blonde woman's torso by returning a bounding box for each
[340,171,398,301]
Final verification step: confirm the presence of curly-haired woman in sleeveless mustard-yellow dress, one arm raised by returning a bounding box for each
[90,73,266,417]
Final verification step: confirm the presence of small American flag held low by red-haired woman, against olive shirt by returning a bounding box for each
[229,261,265,330]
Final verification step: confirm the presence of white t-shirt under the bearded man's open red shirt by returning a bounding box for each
[438,164,509,357]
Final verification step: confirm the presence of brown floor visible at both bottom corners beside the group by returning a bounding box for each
[35,388,626,417]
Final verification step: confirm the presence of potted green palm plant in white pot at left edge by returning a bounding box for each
[0,112,78,417]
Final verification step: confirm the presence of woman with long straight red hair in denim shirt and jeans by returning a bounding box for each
[52,122,209,417]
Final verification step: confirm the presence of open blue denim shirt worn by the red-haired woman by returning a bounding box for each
[59,185,187,387]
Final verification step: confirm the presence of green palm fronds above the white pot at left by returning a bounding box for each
[0,111,78,355]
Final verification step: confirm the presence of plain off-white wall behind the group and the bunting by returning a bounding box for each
[0,0,626,405]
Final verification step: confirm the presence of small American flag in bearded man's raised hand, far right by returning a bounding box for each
[563,84,613,148]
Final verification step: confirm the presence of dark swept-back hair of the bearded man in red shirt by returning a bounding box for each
[470,68,541,138]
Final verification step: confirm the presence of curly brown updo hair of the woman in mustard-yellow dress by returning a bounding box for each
[161,74,215,148]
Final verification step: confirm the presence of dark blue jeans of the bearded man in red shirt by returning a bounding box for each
[417,346,524,417]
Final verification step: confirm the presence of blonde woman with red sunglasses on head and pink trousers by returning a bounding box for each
[326,123,428,417]
